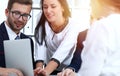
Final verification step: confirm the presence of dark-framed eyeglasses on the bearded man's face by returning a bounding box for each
[10,11,31,21]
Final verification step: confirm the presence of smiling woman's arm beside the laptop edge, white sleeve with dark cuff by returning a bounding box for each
[34,39,46,76]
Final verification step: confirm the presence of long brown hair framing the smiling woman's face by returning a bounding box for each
[35,0,71,45]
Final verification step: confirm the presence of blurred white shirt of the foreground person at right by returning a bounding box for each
[77,14,120,76]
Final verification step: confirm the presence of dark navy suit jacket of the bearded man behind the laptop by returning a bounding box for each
[0,22,34,67]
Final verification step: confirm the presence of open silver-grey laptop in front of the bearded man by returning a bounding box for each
[4,39,34,76]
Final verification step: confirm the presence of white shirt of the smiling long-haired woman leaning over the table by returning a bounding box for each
[35,19,88,70]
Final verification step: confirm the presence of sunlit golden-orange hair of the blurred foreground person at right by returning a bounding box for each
[91,0,120,22]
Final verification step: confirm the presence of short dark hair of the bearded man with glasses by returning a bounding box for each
[7,0,33,10]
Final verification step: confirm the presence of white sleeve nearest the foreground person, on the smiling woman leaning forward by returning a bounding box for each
[52,20,88,64]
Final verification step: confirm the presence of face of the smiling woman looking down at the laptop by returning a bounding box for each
[43,0,64,22]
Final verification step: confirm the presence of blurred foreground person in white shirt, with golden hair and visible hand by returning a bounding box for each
[57,0,120,76]
